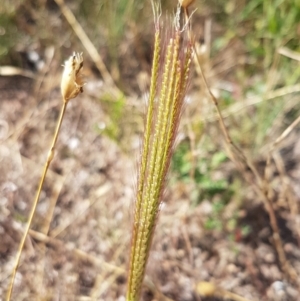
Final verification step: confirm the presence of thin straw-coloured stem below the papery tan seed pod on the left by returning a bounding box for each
[6,100,68,301]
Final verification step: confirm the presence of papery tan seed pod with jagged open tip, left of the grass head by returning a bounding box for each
[60,52,84,101]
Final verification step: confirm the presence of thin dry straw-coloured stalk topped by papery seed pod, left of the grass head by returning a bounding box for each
[6,53,84,301]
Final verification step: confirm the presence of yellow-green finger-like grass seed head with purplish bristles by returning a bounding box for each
[127,13,191,301]
